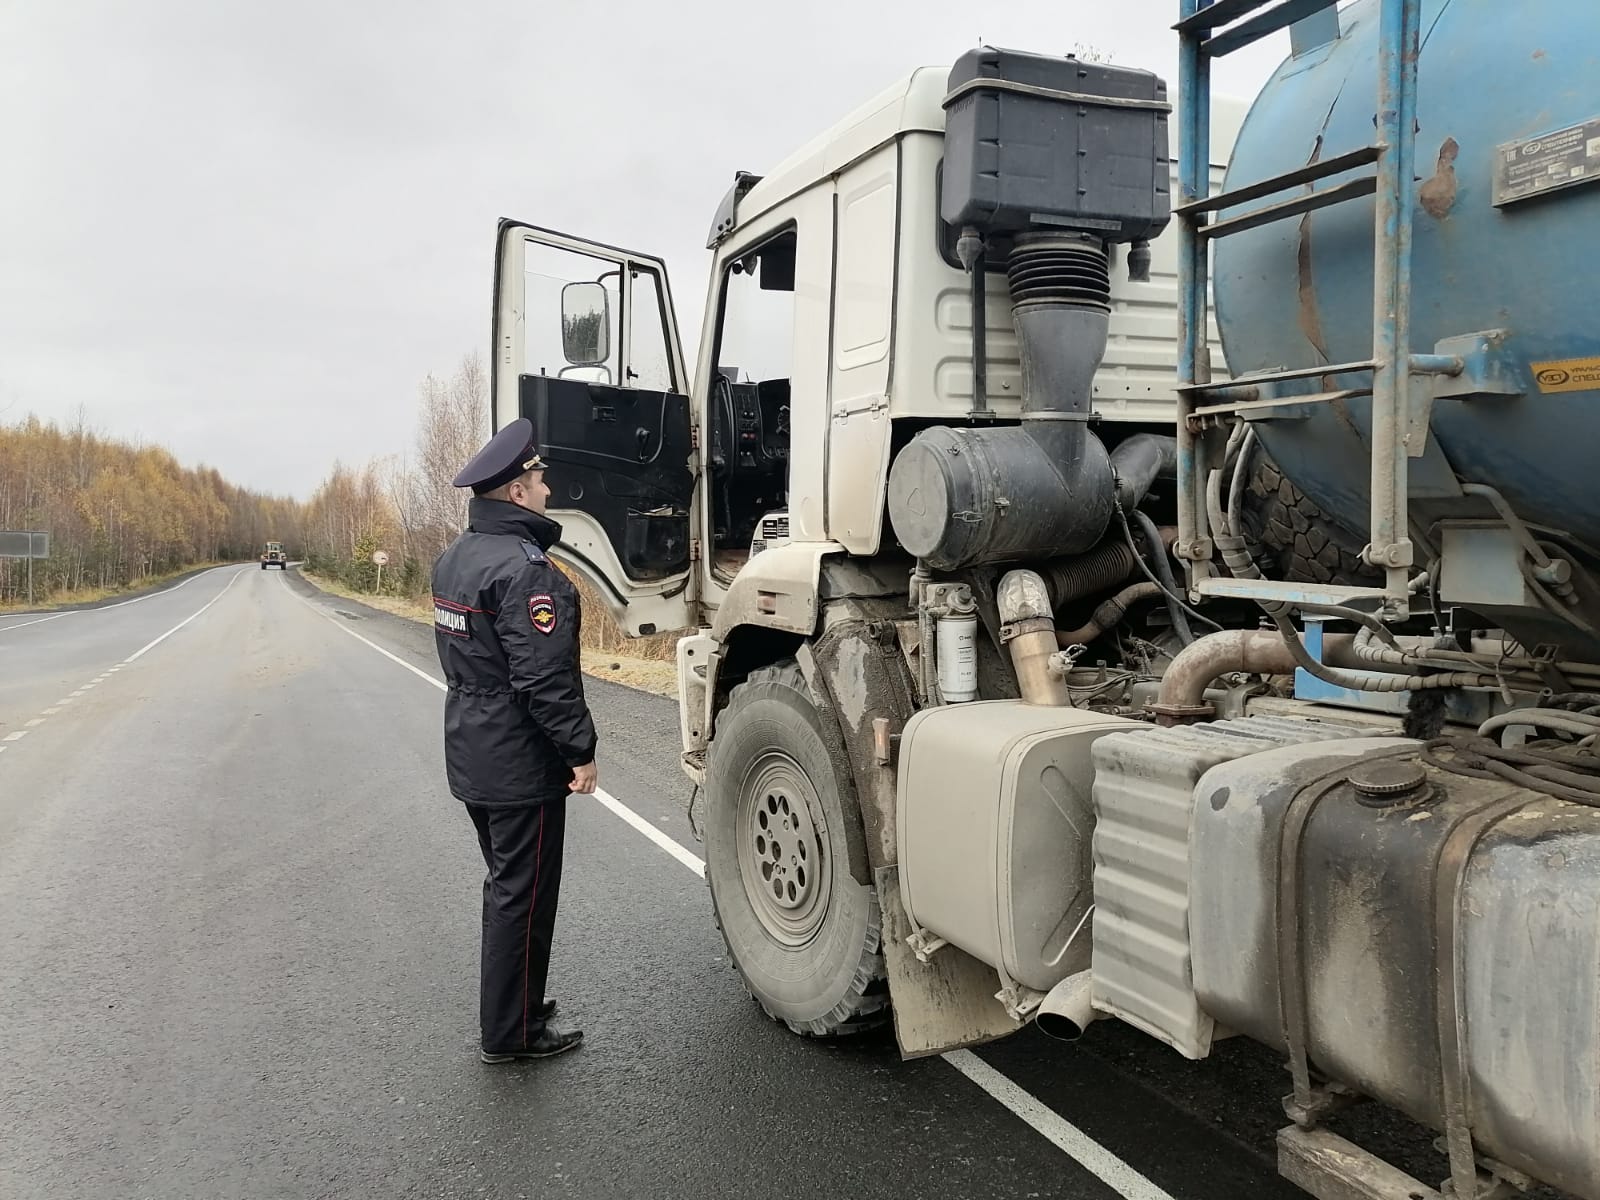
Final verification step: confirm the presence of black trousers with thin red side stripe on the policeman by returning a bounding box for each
[466,797,566,1051]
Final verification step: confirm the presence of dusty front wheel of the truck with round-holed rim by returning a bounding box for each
[706,661,888,1037]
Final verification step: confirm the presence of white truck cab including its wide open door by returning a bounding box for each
[493,67,1243,710]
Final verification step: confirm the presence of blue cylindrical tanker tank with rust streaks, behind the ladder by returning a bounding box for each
[1213,0,1600,569]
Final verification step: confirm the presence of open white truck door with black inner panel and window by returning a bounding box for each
[490,221,696,635]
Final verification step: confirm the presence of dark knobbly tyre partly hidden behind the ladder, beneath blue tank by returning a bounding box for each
[1240,446,1382,584]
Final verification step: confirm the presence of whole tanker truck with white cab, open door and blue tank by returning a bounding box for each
[493,0,1600,1200]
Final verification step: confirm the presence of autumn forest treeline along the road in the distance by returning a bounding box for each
[0,355,490,605]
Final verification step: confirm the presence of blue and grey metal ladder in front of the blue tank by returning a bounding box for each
[1174,0,1427,614]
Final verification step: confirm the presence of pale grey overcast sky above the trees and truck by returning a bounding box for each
[0,0,1286,498]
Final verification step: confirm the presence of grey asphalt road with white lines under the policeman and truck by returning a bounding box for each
[0,566,1472,1200]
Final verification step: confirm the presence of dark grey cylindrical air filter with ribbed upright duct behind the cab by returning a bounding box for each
[890,232,1117,571]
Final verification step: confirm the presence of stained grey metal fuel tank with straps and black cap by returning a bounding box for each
[1189,738,1600,1200]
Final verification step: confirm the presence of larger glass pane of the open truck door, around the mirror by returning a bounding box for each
[522,242,627,384]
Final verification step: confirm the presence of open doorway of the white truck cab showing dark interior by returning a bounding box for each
[710,230,795,574]
